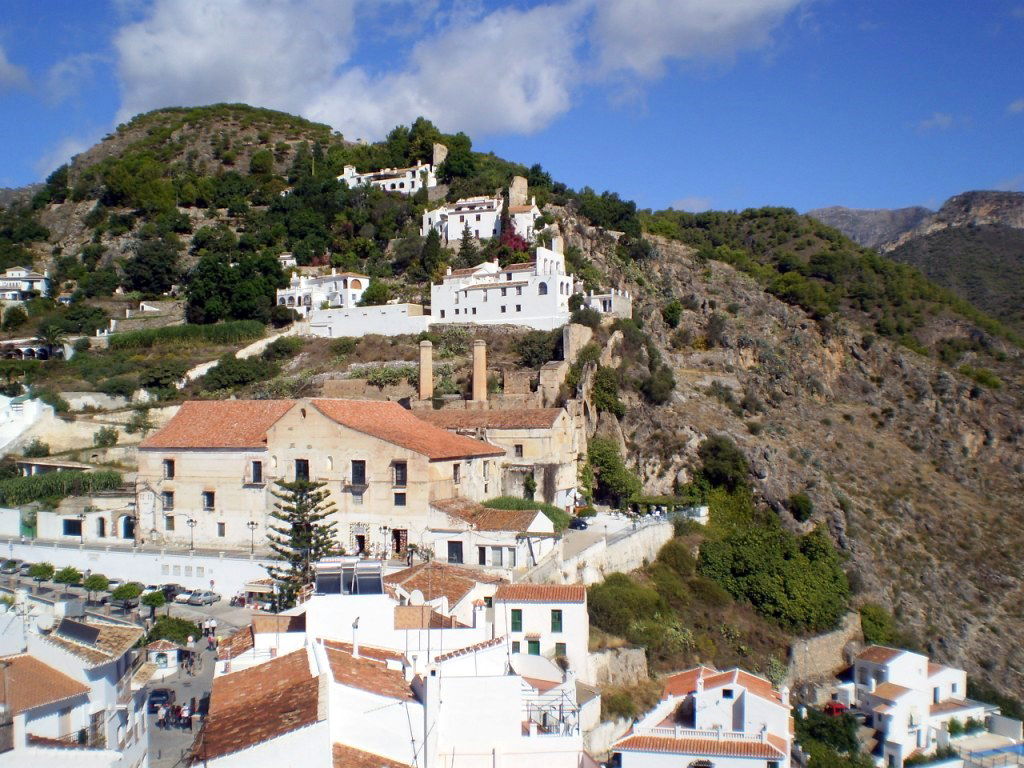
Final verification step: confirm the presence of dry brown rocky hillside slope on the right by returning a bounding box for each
[568,210,1024,694]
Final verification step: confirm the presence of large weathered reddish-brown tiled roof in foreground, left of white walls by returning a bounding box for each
[195,648,322,760]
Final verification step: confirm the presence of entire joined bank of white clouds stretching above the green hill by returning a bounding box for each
[108,0,801,139]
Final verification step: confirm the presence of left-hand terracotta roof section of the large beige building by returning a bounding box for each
[139,400,295,449]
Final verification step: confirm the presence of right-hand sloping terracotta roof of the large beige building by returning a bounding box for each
[312,399,505,460]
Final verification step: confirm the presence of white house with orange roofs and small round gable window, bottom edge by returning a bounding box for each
[612,667,792,768]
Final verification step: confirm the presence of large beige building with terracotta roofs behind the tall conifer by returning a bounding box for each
[136,399,504,556]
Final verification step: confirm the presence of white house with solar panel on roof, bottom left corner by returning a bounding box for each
[0,598,148,768]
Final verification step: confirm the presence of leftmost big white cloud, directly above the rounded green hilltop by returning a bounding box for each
[114,0,354,120]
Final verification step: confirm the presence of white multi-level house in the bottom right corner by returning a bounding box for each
[837,645,1007,768]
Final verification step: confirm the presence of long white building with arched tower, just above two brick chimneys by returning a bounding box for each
[430,247,572,331]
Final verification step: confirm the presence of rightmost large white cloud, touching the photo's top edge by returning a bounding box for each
[592,0,801,78]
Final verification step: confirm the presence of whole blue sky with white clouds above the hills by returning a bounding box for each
[0,0,1024,210]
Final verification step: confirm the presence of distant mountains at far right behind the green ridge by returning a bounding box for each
[808,190,1024,333]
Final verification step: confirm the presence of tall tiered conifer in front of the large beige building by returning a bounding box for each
[266,480,338,608]
